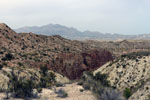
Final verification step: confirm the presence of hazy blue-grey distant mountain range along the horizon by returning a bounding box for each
[15,24,150,40]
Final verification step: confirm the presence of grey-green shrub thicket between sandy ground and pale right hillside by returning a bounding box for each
[80,72,125,100]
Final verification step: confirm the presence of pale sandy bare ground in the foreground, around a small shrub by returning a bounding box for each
[0,83,97,100]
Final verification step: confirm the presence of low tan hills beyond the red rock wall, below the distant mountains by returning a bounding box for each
[84,39,150,57]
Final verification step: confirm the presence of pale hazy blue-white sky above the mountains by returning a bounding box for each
[0,0,150,34]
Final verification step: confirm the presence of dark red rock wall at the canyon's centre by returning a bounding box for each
[47,50,113,80]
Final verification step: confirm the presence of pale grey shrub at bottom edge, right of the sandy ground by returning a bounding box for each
[98,89,126,100]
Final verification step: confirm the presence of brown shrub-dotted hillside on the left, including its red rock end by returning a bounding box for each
[0,23,113,79]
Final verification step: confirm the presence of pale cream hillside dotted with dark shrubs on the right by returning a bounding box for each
[94,52,150,100]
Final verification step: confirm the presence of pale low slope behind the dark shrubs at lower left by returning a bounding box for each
[0,67,69,91]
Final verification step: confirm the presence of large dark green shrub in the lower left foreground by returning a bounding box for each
[9,71,35,98]
